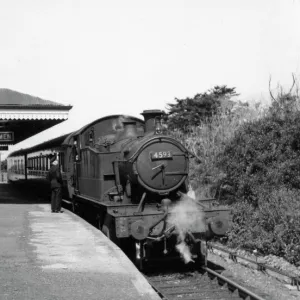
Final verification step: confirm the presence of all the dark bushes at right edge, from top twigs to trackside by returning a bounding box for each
[217,84,300,263]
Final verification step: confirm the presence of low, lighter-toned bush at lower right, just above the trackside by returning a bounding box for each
[228,187,300,263]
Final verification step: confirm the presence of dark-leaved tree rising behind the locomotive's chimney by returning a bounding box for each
[167,85,238,132]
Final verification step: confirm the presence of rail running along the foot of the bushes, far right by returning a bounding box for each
[208,242,300,291]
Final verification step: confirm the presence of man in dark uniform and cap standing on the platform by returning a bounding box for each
[47,156,63,213]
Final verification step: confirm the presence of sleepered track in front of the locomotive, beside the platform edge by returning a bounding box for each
[146,267,266,300]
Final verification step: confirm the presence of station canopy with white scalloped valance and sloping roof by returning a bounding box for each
[0,89,72,150]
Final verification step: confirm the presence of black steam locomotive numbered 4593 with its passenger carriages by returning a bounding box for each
[8,110,230,268]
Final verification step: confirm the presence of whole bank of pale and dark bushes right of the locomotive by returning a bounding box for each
[168,81,300,263]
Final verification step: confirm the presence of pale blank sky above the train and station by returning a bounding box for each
[0,0,300,158]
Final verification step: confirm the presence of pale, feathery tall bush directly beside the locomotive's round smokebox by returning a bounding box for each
[171,102,261,198]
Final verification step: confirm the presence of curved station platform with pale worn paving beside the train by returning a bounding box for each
[0,184,160,300]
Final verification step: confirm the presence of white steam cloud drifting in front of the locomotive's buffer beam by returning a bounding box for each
[168,195,205,263]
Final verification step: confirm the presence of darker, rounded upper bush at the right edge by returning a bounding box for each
[217,106,300,205]
